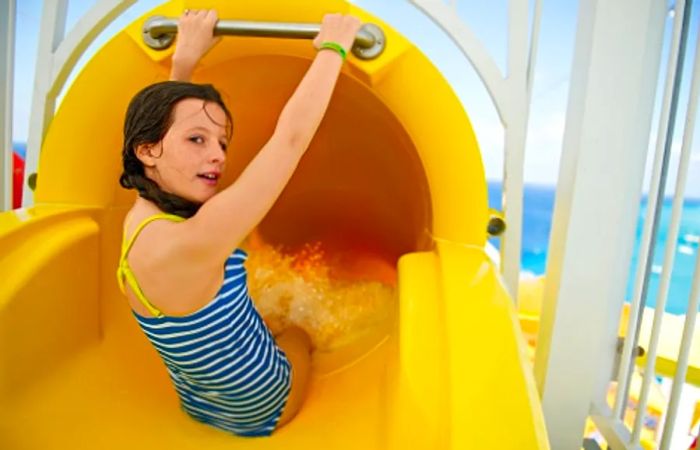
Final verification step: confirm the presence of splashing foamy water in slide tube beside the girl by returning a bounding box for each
[246,244,396,350]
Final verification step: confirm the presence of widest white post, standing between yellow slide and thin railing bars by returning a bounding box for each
[535,0,666,450]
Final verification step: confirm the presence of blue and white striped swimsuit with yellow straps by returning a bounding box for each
[118,215,291,436]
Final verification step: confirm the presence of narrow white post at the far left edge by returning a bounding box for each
[0,0,15,211]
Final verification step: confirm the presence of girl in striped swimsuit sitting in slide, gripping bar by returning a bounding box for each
[118,11,360,436]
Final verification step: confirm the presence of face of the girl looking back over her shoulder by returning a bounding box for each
[136,98,228,203]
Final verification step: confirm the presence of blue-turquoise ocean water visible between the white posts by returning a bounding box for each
[488,182,700,314]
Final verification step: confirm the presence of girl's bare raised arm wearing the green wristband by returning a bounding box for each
[182,14,361,261]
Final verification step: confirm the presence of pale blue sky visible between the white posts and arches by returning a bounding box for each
[13,0,700,197]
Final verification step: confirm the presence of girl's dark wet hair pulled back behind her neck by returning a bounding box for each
[119,81,233,218]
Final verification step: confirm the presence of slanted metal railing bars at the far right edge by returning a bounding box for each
[594,0,700,450]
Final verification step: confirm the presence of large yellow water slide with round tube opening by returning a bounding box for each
[0,0,548,450]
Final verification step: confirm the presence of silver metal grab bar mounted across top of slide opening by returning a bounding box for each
[143,16,386,59]
